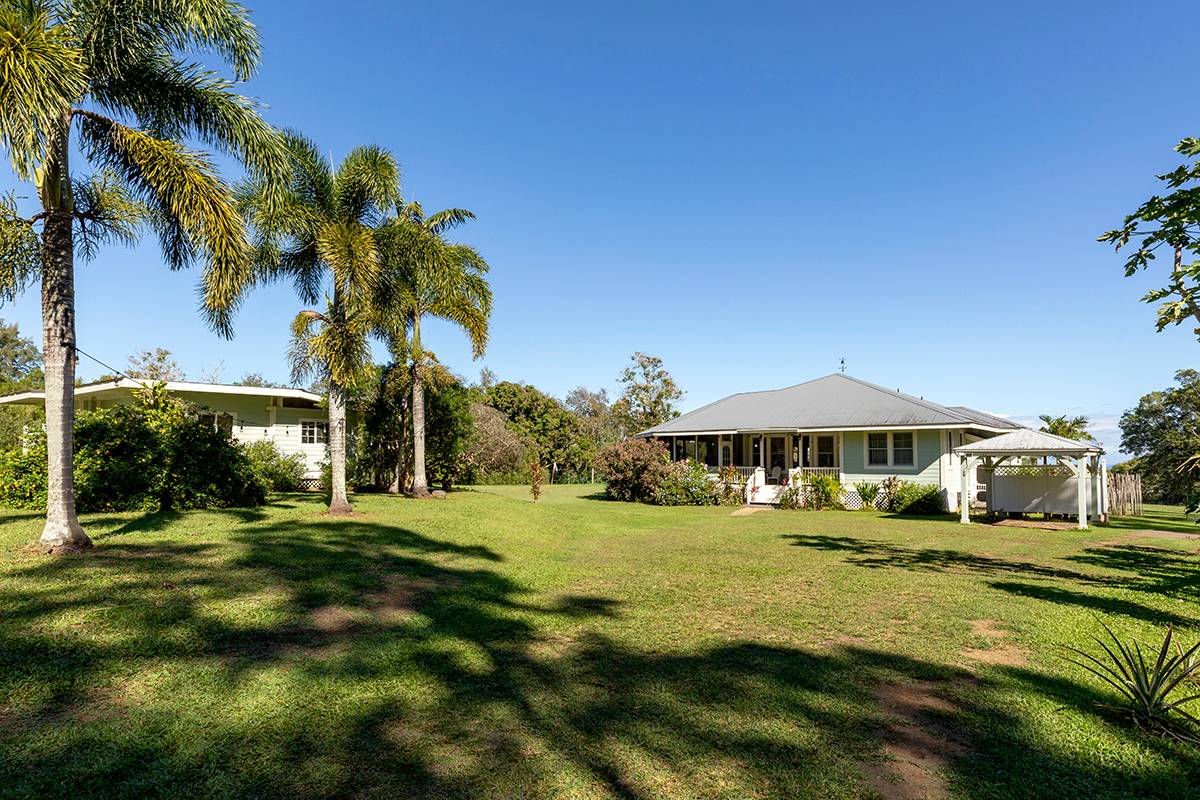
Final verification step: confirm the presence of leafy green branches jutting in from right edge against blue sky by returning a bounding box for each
[1099,138,1200,337]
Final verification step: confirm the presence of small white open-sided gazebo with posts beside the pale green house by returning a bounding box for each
[954,428,1109,528]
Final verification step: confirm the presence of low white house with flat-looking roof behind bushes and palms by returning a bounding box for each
[0,378,329,477]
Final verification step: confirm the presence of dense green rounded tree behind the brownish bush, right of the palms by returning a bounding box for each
[485,380,592,474]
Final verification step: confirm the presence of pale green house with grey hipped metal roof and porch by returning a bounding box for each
[637,373,1022,509]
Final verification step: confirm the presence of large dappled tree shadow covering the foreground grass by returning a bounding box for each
[0,519,1200,800]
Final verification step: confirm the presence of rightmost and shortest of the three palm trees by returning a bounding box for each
[377,203,492,497]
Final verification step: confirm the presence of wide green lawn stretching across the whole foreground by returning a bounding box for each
[0,486,1200,799]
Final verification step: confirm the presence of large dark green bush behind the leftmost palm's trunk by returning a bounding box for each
[0,392,266,511]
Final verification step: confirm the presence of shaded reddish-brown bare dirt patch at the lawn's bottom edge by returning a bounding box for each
[860,681,971,800]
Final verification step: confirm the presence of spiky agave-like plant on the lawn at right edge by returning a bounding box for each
[1066,621,1200,742]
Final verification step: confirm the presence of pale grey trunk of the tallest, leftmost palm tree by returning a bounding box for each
[38,122,91,552]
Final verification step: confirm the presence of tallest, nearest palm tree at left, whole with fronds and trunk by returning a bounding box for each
[0,0,286,551]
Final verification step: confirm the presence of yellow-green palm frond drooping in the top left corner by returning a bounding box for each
[0,2,86,180]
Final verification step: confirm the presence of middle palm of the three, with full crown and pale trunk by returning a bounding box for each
[240,134,400,513]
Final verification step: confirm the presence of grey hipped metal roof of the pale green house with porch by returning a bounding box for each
[638,373,1019,437]
